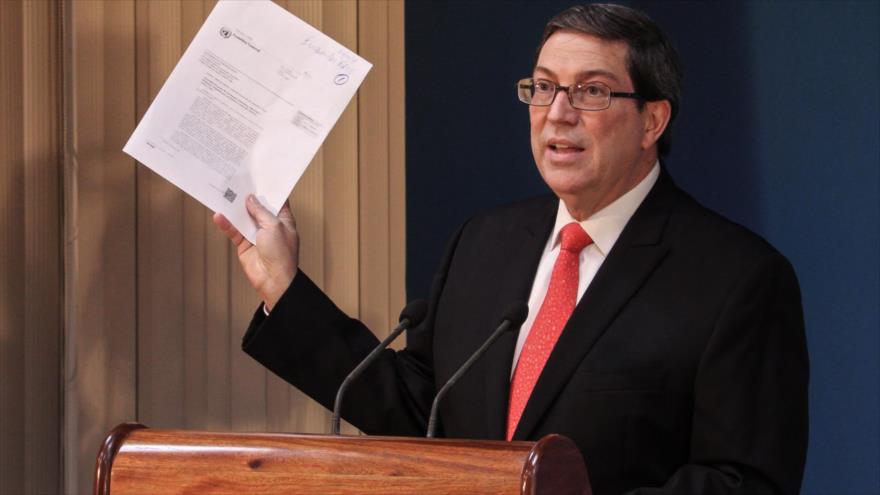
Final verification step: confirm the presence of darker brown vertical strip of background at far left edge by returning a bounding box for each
[0,2,64,495]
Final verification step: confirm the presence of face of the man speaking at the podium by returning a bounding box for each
[529,30,656,219]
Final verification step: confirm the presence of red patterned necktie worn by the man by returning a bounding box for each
[507,222,593,440]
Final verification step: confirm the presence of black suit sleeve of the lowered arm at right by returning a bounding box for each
[630,253,809,495]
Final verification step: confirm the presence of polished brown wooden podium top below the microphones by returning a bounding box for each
[95,423,592,495]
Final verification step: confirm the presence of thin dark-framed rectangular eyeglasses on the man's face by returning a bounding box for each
[516,78,642,111]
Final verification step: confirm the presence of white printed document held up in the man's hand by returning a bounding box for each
[123,0,372,242]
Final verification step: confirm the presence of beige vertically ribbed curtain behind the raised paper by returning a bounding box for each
[0,0,405,493]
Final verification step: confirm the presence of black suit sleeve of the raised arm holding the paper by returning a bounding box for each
[242,223,460,436]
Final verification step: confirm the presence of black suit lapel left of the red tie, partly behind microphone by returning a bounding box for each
[481,197,559,439]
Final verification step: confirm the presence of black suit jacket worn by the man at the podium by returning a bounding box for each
[243,172,808,495]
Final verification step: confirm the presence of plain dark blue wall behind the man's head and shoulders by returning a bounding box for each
[406,0,880,494]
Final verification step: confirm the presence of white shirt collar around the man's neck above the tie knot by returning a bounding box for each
[550,161,660,257]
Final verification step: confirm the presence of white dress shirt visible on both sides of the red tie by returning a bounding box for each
[510,162,660,376]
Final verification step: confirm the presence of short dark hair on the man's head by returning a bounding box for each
[538,4,682,155]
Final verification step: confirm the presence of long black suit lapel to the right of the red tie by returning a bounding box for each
[511,172,677,439]
